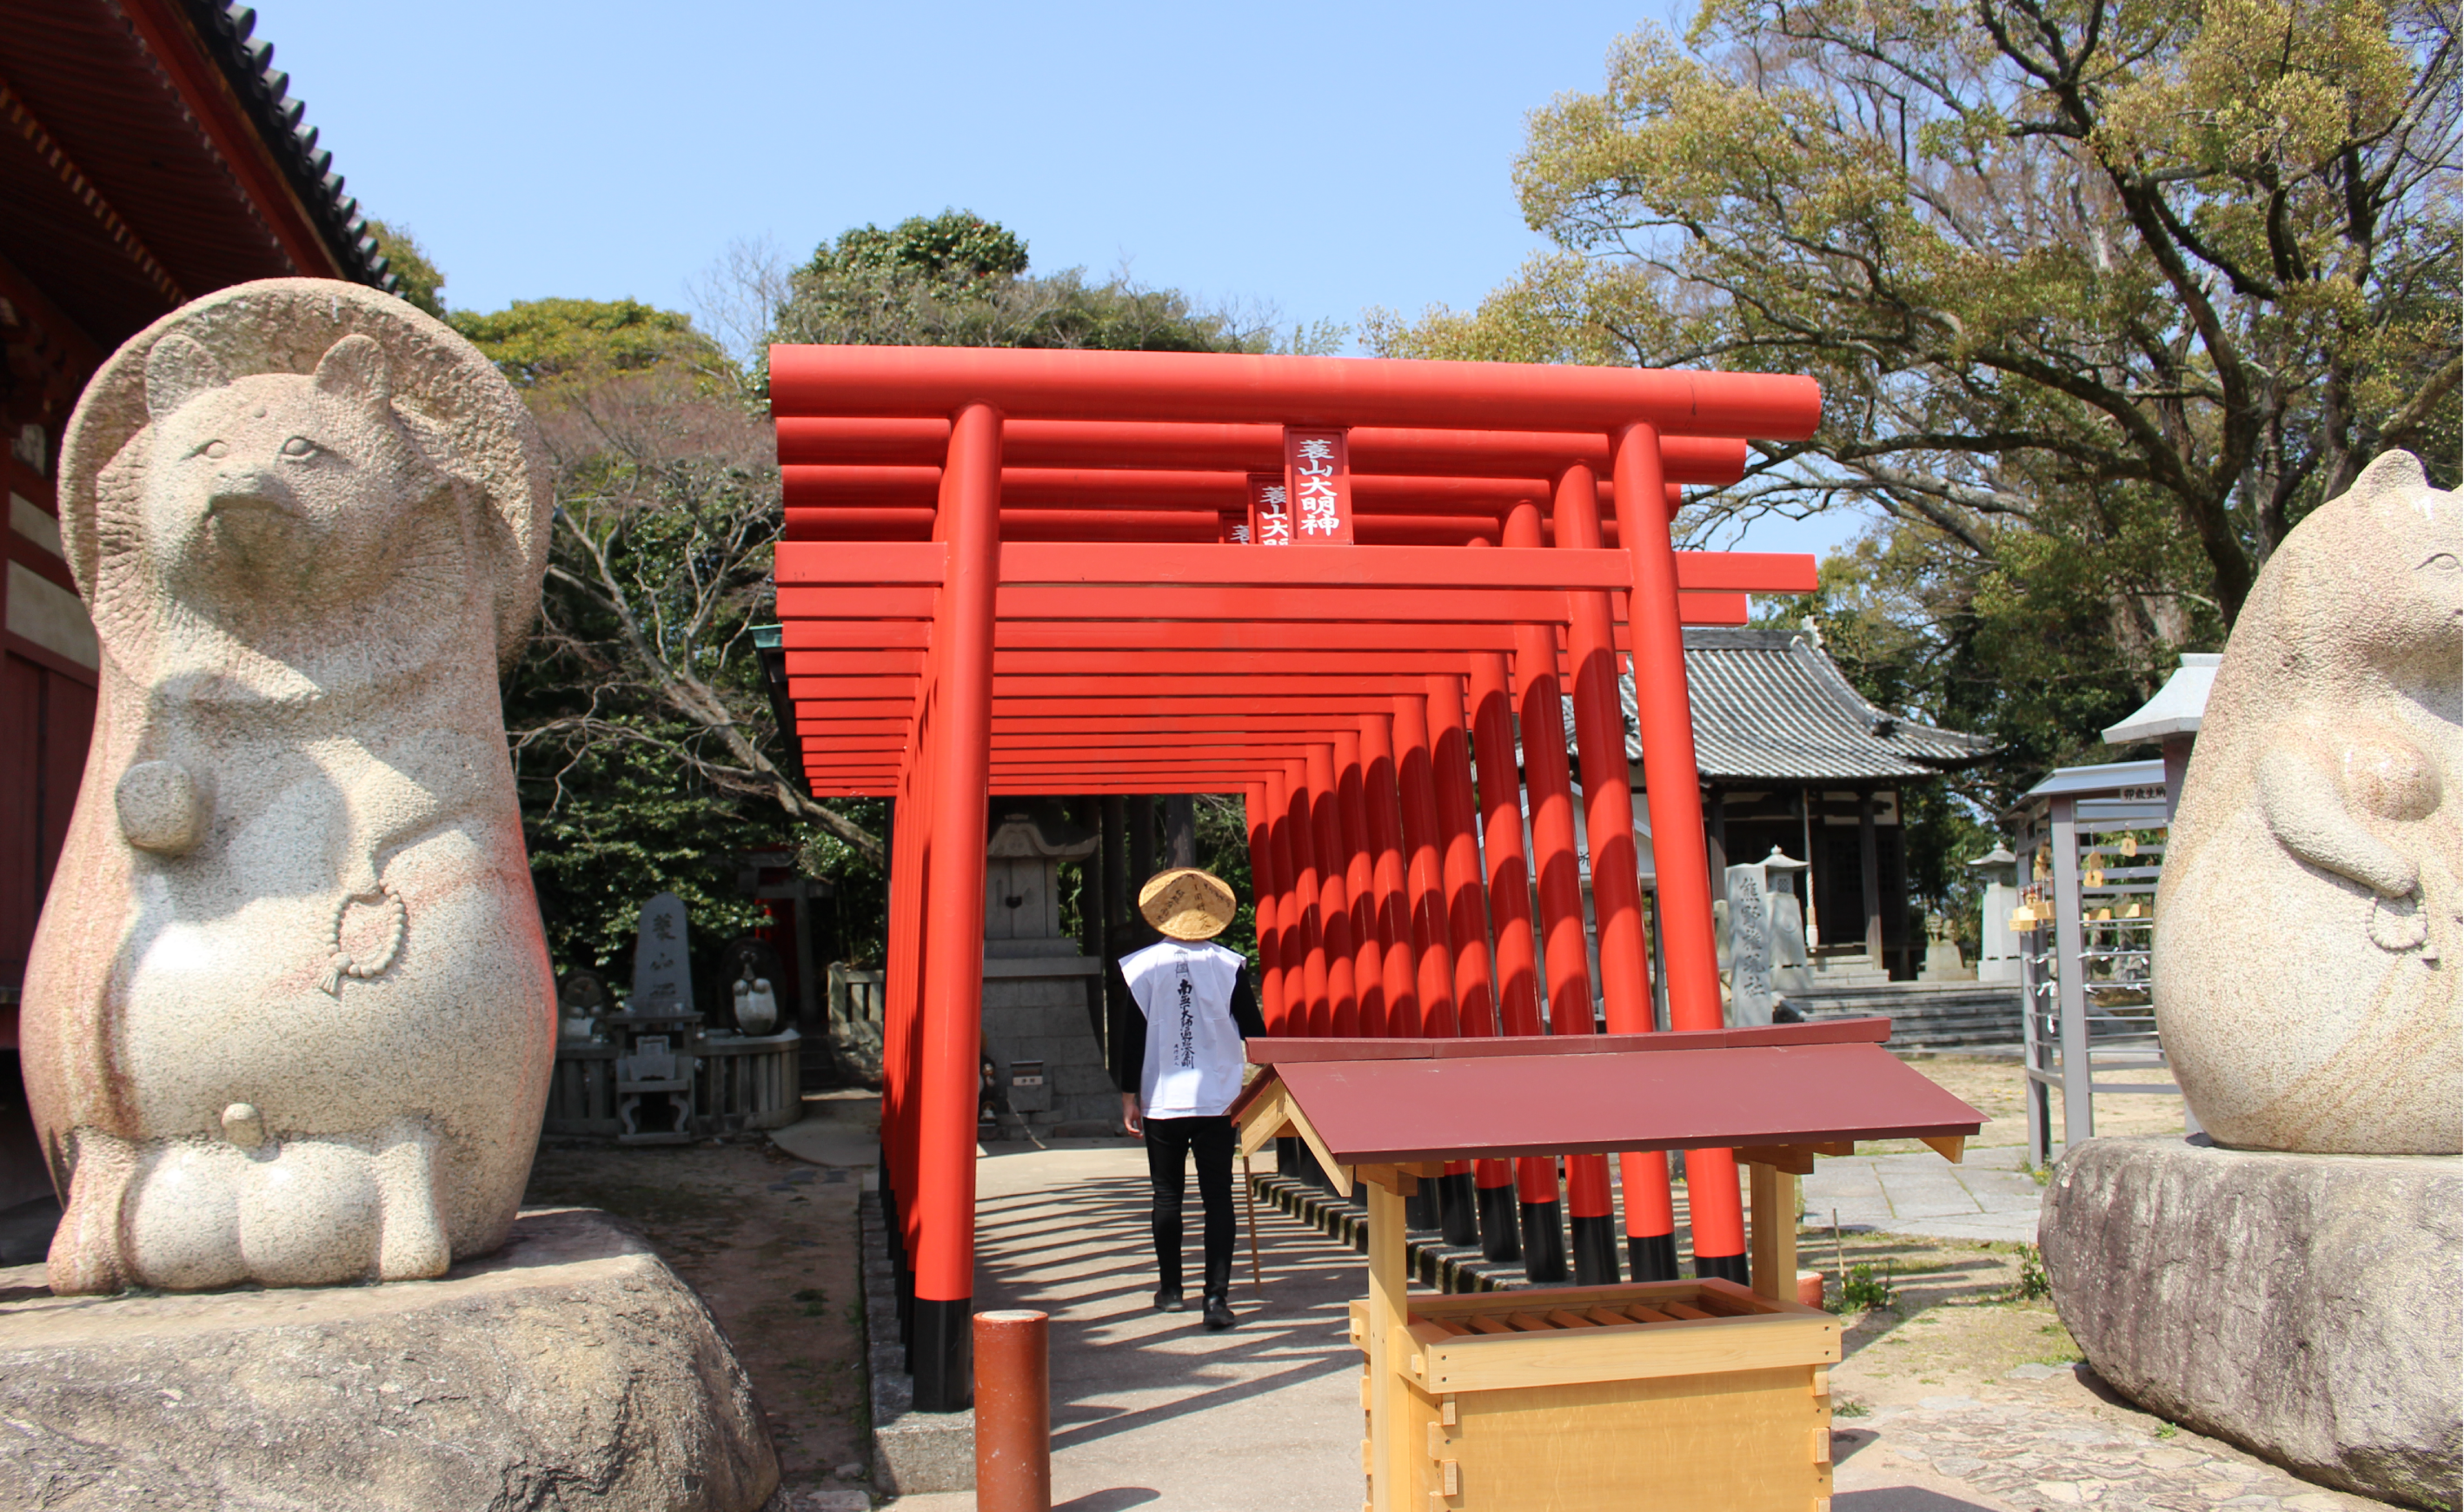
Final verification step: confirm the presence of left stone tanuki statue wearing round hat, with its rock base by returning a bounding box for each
[0,278,779,1512]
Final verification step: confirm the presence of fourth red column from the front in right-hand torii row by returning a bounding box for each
[1471,650,1562,1270]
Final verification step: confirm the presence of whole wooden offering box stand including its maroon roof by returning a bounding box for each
[1232,1019,1981,1512]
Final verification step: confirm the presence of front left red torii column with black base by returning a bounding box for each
[912,404,1000,1411]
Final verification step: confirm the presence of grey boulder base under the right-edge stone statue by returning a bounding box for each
[2038,1135,2464,1507]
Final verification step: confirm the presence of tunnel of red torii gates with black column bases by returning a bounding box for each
[771,348,1821,1411]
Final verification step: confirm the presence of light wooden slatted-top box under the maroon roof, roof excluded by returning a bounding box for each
[1352,1281,1841,1512]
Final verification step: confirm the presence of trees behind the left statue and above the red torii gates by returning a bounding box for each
[416,212,1338,968]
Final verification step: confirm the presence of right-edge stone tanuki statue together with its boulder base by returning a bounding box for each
[2040,453,2464,1507]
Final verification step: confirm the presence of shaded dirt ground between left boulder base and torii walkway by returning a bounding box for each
[525,1117,873,1489]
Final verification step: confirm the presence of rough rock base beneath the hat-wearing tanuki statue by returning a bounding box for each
[0,1209,779,1512]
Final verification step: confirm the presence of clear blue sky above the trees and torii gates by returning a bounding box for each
[256,0,1853,549]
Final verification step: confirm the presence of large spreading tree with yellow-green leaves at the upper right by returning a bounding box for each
[1370,0,2464,842]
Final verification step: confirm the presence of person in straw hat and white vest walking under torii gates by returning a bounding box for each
[1112,867,1266,1330]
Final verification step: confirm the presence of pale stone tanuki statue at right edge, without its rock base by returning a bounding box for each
[2154,451,2464,1155]
